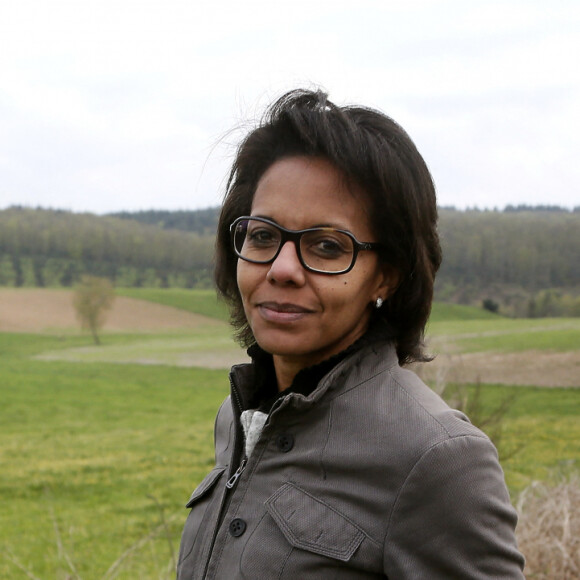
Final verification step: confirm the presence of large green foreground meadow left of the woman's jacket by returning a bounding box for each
[0,335,228,579]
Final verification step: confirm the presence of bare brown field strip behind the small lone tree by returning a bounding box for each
[0,288,223,333]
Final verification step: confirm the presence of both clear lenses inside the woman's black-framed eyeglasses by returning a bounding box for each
[234,219,354,272]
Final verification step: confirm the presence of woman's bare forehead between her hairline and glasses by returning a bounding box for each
[251,157,371,241]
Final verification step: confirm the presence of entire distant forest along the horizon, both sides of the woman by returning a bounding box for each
[0,206,580,316]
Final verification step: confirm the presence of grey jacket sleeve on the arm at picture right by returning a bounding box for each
[384,435,524,580]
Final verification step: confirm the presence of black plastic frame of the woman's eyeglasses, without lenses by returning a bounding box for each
[230,216,382,276]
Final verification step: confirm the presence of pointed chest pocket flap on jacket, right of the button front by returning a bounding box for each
[266,482,366,562]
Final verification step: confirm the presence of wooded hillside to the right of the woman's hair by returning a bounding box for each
[437,210,580,316]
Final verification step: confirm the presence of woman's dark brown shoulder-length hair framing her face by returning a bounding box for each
[215,90,441,364]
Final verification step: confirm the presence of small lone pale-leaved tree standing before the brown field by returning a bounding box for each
[74,276,115,344]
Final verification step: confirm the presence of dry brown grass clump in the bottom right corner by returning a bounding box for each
[516,474,580,580]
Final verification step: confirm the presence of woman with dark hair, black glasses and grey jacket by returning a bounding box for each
[178,91,523,580]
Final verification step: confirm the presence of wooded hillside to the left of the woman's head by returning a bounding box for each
[0,208,214,288]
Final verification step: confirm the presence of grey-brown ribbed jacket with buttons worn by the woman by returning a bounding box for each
[178,343,524,580]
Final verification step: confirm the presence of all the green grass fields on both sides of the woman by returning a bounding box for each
[0,290,580,580]
